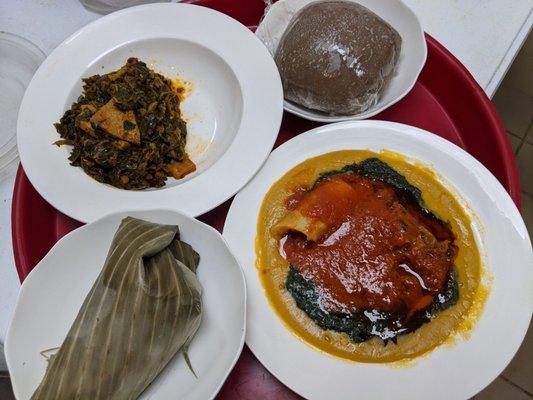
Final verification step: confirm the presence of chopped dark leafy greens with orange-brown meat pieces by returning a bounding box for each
[55,58,196,189]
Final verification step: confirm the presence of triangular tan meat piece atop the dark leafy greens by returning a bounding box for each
[91,99,141,144]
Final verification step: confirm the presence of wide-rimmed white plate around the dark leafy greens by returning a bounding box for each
[17,3,283,222]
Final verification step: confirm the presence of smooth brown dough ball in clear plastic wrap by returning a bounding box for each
[275,1,402,115]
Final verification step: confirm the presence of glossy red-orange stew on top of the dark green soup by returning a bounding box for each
[282,174,457,321]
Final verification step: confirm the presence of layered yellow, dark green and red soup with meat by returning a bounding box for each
[256,150,487,362]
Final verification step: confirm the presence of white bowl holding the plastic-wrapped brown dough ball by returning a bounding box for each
[256,0,427,122]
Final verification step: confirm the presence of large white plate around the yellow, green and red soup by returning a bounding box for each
[224,121,533,400]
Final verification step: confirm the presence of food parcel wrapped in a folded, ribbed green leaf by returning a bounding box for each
[32,217,202,400]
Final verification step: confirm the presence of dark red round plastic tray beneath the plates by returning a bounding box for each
[12,0,521,400]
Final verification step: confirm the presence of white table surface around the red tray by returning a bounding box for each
[0,0,533,370]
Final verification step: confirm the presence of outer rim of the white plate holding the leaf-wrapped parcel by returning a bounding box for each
[4,208,248,400]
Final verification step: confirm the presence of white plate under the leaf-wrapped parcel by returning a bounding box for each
[5,210,246,400]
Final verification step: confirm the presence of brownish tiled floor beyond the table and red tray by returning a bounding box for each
[0,34,533,400]
